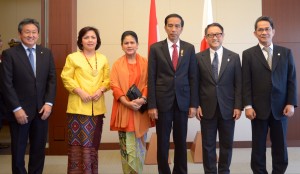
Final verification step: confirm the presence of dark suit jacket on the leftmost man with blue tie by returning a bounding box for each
[1,44,56,120]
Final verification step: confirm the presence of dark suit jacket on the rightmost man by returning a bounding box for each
[242,45,297,120]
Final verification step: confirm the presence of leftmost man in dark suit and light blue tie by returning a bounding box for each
[1,19,56,174]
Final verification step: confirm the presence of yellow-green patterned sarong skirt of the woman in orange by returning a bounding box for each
[119,131,147,174]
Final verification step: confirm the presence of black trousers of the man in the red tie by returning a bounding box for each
[156,101,188,174]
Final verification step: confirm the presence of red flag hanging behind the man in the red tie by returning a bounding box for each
[148,0,159,53]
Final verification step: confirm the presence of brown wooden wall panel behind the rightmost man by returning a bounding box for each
[262,0,300,147]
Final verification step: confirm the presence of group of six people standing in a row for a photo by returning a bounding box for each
[1,14,297,174]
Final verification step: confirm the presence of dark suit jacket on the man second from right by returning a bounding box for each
[196,47,242,119]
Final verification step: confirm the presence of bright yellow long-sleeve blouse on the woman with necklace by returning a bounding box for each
[61,51,110,116]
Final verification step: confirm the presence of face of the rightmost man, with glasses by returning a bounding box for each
[254,21,275,46]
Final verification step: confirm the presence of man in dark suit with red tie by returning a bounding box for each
[148,14,198,174]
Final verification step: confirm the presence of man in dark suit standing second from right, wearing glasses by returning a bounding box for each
[196,23,242,174]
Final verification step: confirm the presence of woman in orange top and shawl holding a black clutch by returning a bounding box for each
[110,31,151,174]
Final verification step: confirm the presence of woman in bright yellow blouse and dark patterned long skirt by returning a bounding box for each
[61,27,110,173]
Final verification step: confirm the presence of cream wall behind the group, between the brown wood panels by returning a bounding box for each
[77,0,262,142]
